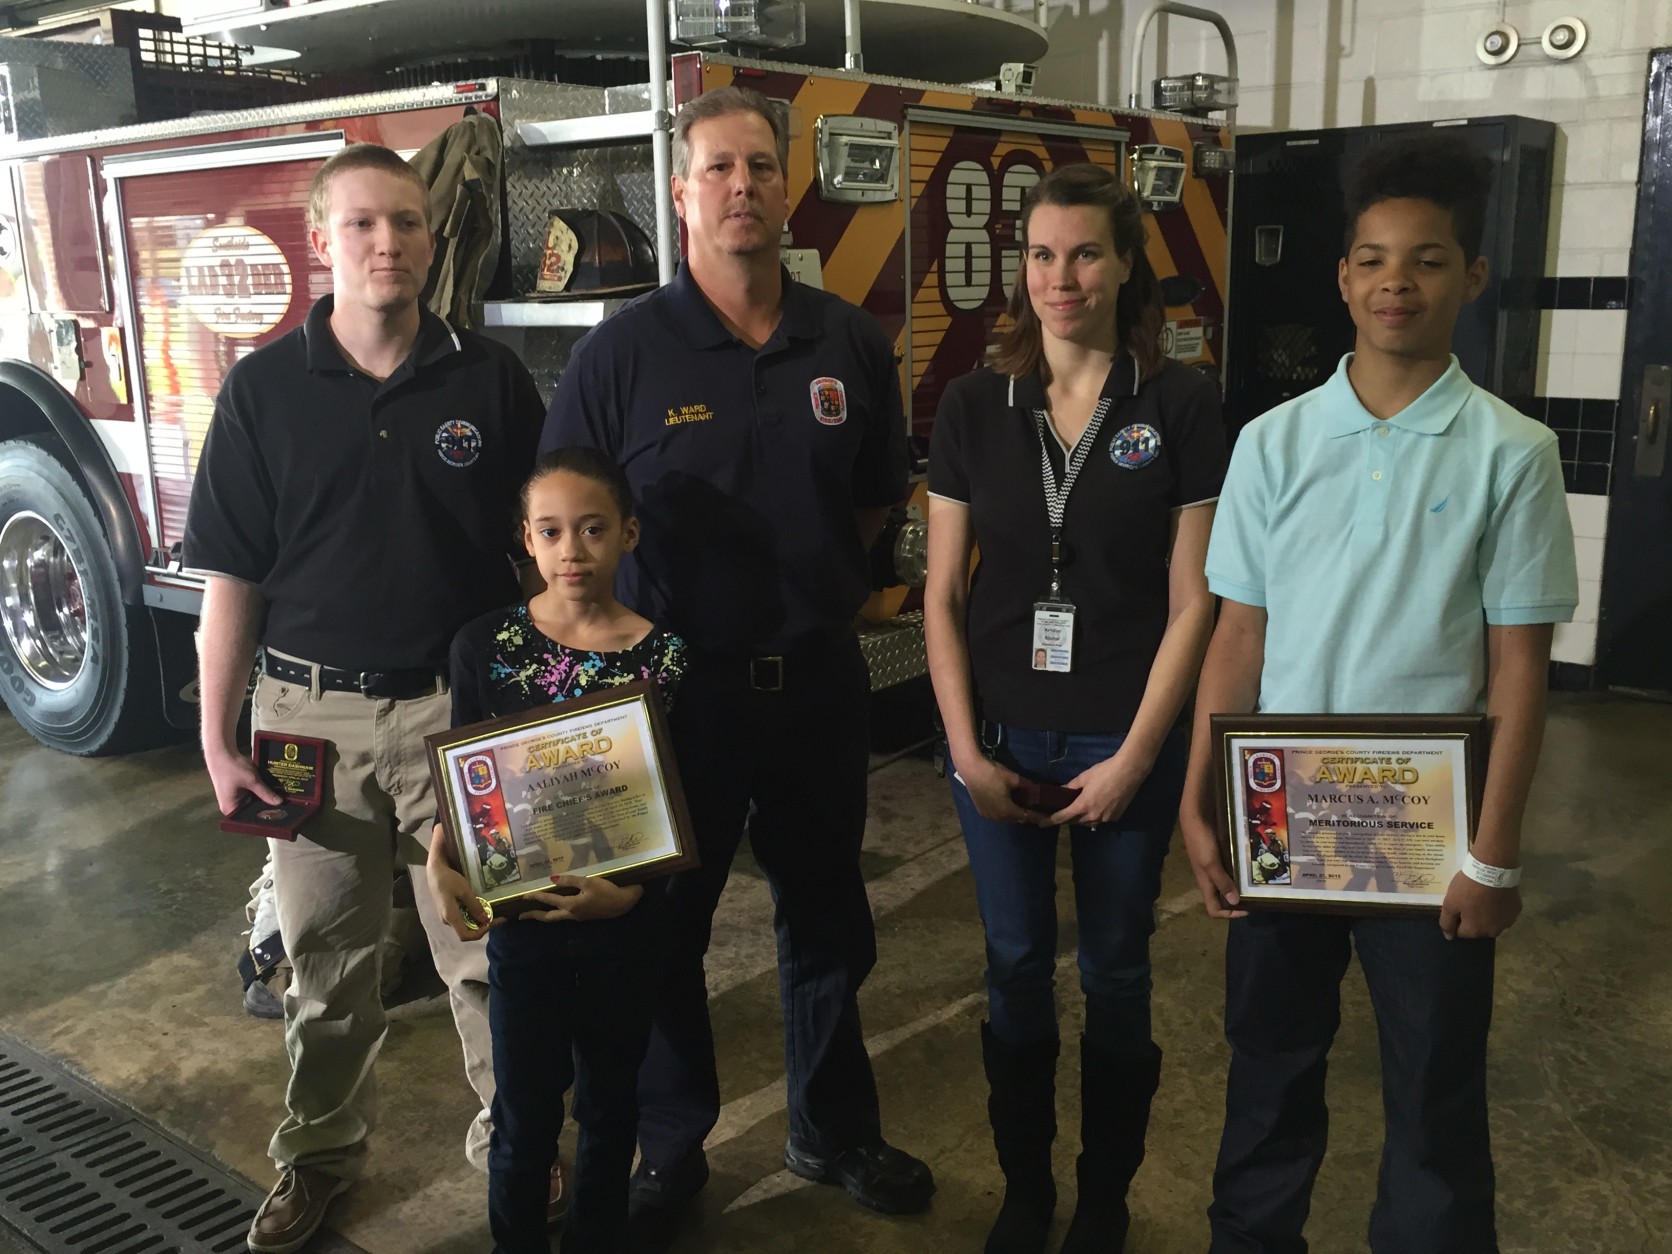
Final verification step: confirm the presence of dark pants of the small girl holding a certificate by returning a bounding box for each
[488,916,662,1254]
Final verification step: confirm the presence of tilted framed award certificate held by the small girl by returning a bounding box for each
[425,681,697,915]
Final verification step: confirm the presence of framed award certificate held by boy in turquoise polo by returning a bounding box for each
[1212,714,1486,915]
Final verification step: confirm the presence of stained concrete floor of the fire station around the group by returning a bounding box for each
[0,697,1672,1254]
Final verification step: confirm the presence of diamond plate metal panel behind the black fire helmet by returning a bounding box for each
[500,79,668,296]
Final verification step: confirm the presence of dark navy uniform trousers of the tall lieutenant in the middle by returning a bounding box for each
[639,635,881,1167]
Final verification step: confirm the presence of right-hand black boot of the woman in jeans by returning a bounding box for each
[1062,1037,1160,1254]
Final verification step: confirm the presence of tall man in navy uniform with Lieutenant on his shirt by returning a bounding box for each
[542,87,935,1246]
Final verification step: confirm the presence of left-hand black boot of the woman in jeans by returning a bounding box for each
[981,1023,1058,1254]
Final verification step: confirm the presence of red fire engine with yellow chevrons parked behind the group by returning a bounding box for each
[0,0,1229,754]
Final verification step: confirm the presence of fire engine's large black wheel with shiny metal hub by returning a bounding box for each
[0,435,164,754]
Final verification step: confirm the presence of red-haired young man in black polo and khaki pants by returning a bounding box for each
[184,144,542,1254]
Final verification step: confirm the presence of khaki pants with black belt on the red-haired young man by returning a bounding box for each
[252,675,493,1179]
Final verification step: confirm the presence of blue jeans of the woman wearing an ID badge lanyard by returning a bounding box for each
[951,722,1185,1053]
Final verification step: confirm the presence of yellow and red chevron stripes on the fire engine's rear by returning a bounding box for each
[701,57,1229,436]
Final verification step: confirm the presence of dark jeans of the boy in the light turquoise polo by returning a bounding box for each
[1207,913,1498,1254]
